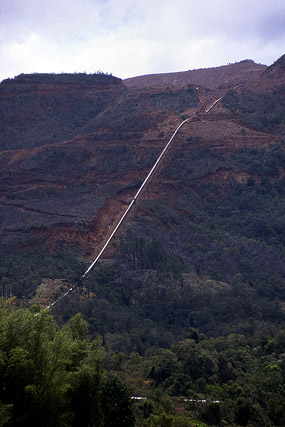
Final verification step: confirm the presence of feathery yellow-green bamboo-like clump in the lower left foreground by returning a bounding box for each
[0,307,133,427]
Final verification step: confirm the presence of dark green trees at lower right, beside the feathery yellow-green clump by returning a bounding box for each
[115,329,285,427]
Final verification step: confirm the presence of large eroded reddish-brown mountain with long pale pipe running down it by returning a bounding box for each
[0,57,285,334]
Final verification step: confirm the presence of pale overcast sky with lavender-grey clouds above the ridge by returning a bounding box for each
[0,0,285,81]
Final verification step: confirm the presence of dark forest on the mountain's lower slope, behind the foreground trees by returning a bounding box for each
[1,145,285,354]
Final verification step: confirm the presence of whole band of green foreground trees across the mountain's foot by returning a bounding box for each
[0,300,285,427]
